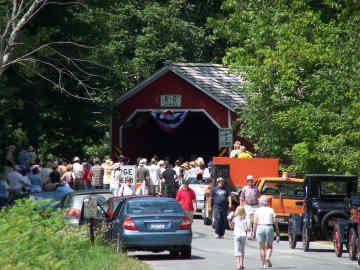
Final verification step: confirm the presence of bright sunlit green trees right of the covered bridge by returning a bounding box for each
[212,0,360,174]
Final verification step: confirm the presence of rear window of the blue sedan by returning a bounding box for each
[127,200,183,215]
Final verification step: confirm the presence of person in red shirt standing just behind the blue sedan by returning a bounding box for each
[176,181,197,223]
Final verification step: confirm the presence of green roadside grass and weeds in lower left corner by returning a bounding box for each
[0,199,151,270]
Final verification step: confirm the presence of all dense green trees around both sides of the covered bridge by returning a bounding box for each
[0,0,360,174]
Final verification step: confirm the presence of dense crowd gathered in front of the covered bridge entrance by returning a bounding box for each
[0,145,211,207]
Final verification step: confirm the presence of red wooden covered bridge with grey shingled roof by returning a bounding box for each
[111,63,247,160]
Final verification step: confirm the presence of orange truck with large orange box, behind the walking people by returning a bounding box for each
[202,157,304,227]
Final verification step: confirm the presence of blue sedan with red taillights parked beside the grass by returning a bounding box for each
[109,196,192,258]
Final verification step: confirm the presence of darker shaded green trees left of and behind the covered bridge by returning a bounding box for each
[0,0,224,158]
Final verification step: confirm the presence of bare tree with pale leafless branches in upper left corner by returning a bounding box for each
[0,0,106,100]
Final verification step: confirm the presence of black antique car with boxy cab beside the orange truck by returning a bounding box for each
[288,174,357,251]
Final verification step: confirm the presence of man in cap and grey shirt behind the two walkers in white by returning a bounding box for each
[240,175,261,240]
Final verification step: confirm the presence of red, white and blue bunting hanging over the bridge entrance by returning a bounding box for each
[151,110,189,132]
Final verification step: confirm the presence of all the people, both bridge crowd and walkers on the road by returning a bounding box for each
[0,141,279,269]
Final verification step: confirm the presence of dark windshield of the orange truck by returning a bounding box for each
[261,181,304,198]
